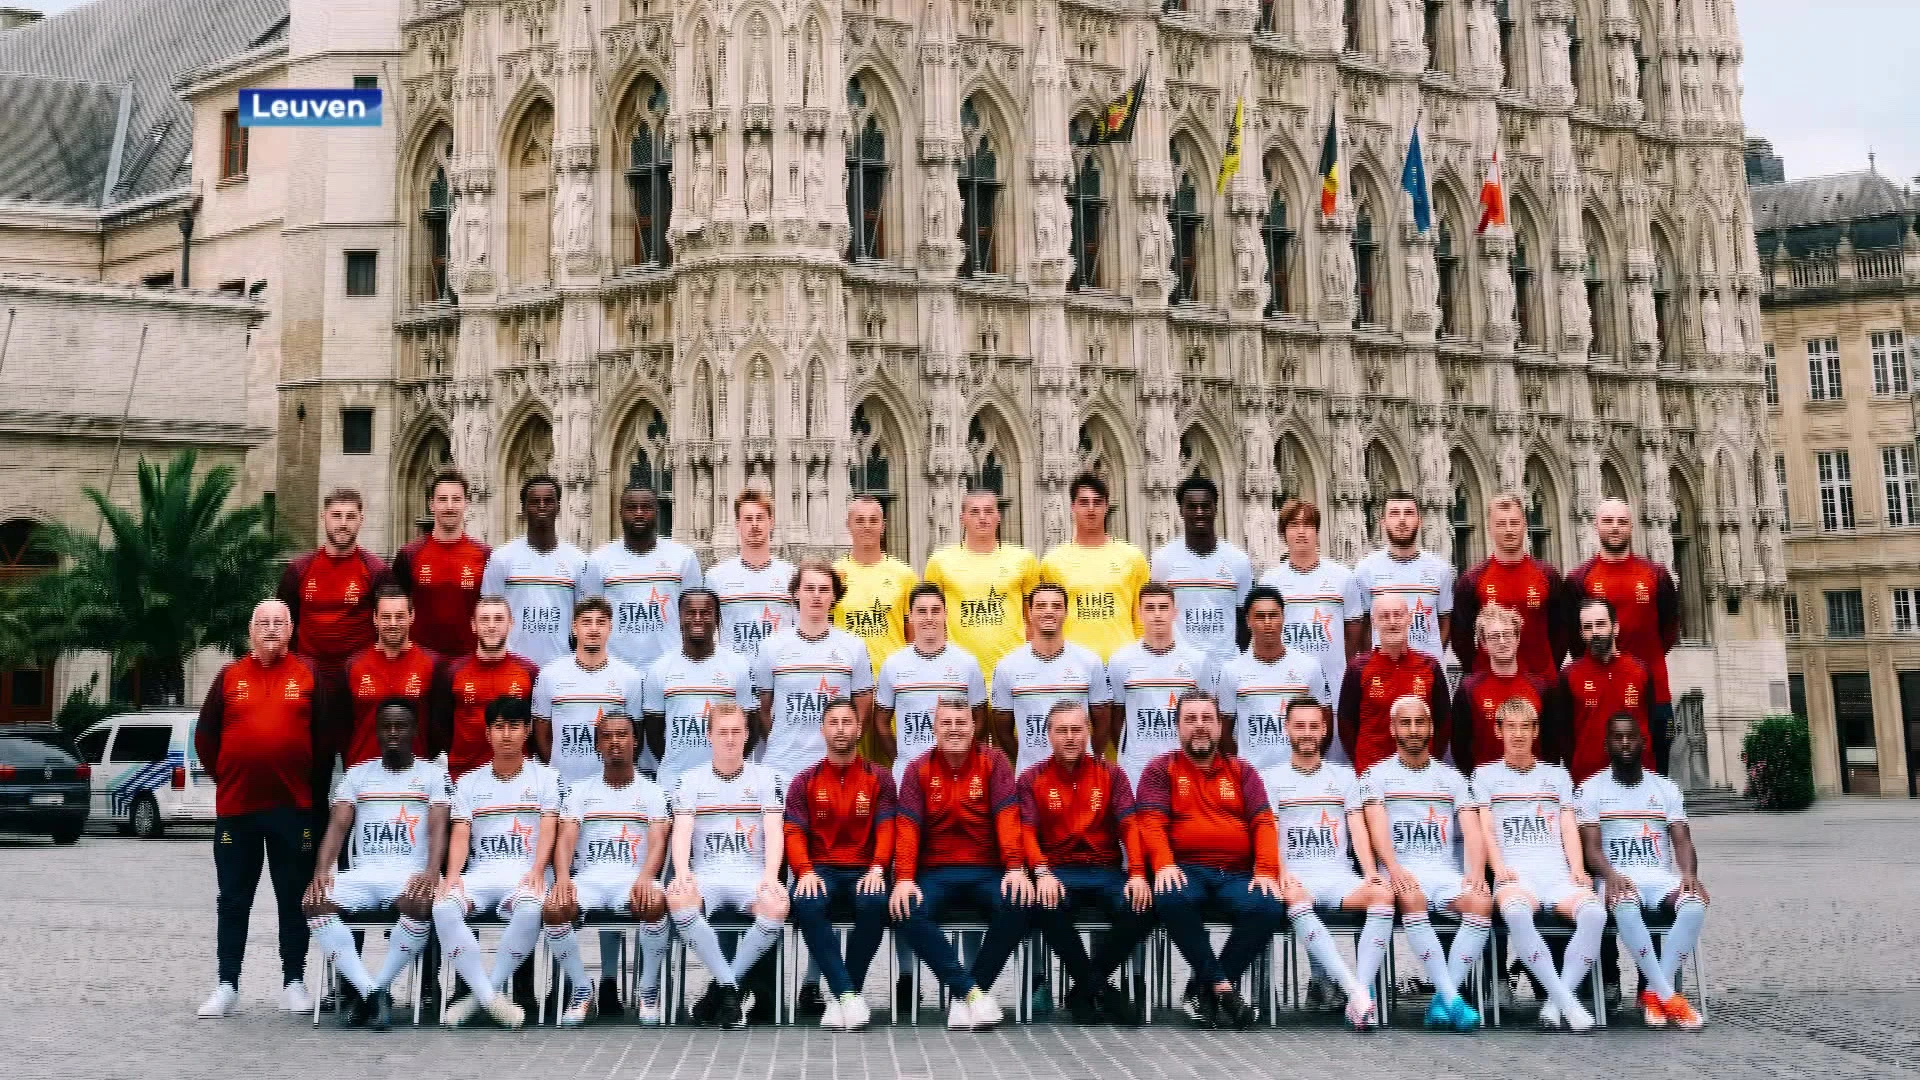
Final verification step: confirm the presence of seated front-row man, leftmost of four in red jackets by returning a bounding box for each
[785,698,895,1032]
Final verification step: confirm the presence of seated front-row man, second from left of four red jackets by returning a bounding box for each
[887,696,1033,1030]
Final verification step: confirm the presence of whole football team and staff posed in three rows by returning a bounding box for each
[196,471,1709,1032]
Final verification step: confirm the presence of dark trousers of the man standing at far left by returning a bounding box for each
[213,807,313,986]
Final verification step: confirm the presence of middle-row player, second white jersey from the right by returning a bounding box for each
[1106,580,1213,784]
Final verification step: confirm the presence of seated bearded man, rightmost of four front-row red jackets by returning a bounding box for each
[1135,690,1286,1030]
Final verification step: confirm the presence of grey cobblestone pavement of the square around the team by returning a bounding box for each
[0,799,1920,1080]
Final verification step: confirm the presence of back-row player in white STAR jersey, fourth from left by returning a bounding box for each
[580,484,705,671]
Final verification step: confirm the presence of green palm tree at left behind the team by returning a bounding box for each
[33,450,286,705]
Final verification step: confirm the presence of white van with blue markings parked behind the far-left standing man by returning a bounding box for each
[75,711,213,840]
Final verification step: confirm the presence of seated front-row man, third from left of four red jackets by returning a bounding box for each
[1016,701,1154,1024]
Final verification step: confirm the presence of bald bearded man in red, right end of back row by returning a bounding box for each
[1559,500,1680,776]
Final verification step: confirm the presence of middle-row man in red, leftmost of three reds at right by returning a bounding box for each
[1334,596,1453,774]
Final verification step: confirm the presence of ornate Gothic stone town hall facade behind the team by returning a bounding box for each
[280,0,1786,778]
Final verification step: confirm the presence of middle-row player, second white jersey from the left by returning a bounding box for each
[645,586,760,794]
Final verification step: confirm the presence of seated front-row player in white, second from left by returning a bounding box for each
[434,698,561,1028]
